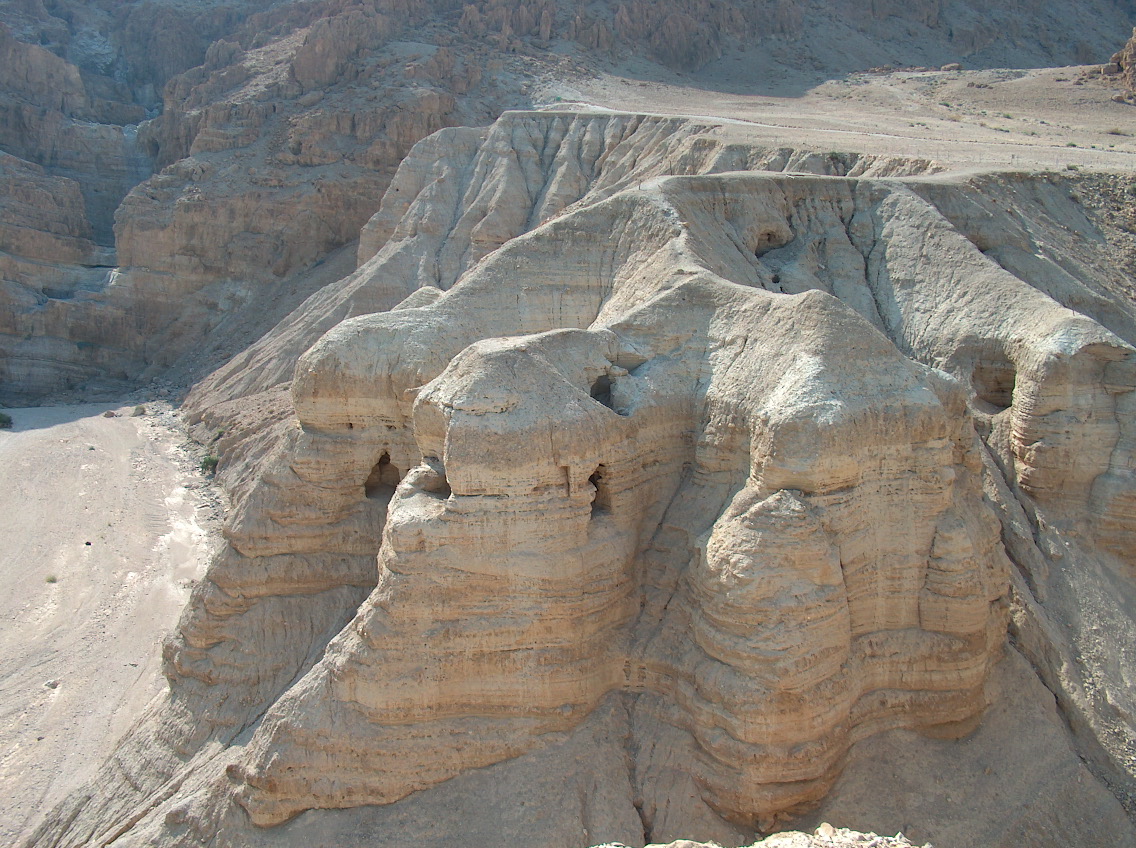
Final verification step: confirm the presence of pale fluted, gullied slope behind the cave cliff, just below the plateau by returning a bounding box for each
[187,113,938,406]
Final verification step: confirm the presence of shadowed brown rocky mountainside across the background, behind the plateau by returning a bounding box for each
[0,0,1124,402]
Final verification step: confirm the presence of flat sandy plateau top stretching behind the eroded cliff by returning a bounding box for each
[534,57,1136,172]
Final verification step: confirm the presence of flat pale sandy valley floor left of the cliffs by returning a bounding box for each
[0,404,217,845]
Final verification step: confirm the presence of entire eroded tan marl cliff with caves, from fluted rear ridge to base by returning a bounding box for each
[24,113,1136,846]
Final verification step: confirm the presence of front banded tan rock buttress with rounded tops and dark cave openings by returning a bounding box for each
[177,138,1005,824]
